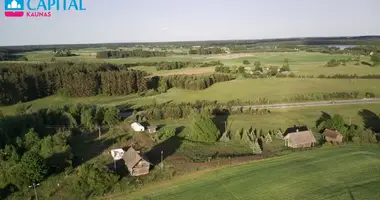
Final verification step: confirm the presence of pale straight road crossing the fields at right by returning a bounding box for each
[233,99,380,109]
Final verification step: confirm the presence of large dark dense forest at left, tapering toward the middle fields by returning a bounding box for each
[0,62,233,105]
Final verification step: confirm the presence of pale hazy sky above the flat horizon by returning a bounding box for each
[0,0,380,46]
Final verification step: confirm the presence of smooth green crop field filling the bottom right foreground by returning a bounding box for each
[112,146,380,200]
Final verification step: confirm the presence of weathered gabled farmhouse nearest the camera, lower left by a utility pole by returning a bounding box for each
[123,147,151,176]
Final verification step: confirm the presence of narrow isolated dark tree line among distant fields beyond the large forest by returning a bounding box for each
[96,49,166,58]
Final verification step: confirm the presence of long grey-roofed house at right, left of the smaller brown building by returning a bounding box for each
[284,129,317,148]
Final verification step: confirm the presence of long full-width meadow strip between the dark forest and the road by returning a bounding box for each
[0,78,380,114]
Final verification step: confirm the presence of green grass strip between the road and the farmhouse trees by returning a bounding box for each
[151,103,380,132]
